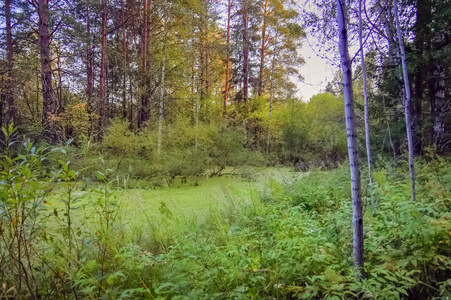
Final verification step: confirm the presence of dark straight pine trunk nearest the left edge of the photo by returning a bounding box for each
[5,0,16,124]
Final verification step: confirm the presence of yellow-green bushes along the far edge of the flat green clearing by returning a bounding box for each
[102,120,265,187]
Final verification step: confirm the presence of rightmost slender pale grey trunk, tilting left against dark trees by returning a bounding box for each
[393,0,415,201]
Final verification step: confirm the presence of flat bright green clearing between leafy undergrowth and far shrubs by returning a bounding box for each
[49,167,308,226]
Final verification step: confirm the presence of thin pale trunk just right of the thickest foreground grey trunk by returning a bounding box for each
[359,0,373,189]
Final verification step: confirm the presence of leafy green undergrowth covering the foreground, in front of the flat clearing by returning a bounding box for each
[0,128,451,299]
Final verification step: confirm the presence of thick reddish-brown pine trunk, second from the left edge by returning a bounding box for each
[38,0,55,124]
